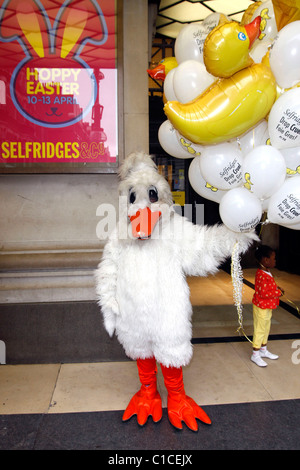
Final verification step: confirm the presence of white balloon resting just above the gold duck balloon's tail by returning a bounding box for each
[173,60,216,103]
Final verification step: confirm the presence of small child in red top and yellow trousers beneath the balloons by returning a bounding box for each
[251,245,283,367]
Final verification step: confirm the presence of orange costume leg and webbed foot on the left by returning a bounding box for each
[123,358,162,426]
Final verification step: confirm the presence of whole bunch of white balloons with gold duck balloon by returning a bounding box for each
[154,0,300,232]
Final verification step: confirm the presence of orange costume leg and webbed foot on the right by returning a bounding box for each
[161,364,211,431]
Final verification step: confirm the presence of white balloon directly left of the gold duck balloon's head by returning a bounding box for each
[175,23,208,64]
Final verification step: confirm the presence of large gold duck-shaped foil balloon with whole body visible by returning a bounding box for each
[164,17,276,145]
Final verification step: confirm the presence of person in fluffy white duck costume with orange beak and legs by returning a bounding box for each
[95,152,256,431]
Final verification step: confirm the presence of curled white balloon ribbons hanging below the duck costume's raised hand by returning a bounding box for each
[231,242,253,344]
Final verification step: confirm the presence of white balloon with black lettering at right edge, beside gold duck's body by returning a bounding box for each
[268,86,300,149]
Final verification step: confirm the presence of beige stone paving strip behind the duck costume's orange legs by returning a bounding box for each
[0,340,300,414]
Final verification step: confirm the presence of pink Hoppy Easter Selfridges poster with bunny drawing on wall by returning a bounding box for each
[0,0,118,172]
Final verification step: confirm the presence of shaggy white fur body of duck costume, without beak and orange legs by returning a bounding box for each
[95,154,256,367]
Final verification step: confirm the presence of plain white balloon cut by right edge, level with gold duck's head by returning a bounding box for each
[269,21,300,88]
